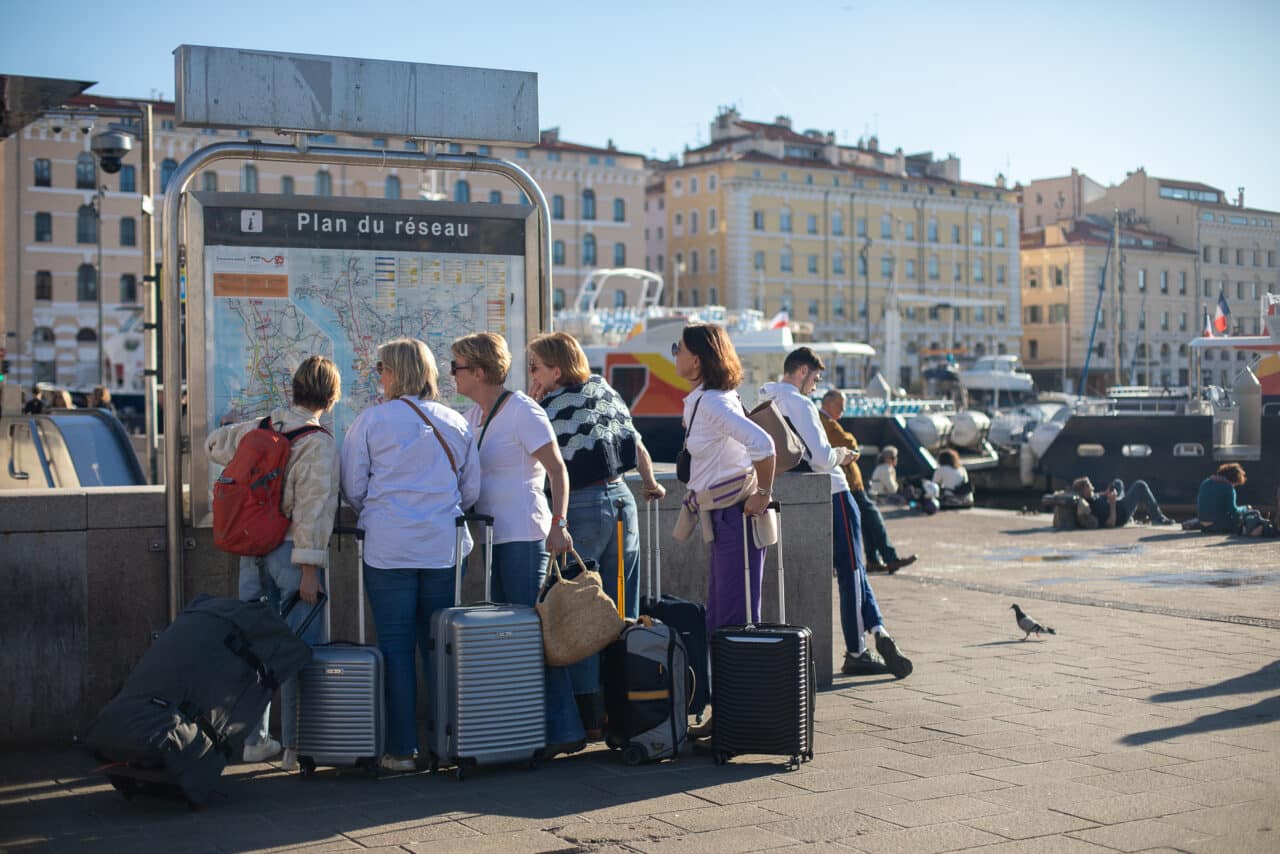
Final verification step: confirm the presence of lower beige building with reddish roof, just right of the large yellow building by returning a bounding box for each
[1021,216,1203,393]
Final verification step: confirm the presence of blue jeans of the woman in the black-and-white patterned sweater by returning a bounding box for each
[566,480,640,694]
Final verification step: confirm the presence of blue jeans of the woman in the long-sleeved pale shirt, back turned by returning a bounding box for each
[365,562,454,757]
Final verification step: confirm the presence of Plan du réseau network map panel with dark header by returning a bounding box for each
[186,192,547,526]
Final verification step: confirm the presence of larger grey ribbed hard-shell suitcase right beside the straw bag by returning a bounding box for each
[428,515,547,780]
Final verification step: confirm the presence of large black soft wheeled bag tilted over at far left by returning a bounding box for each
[83,594,325,807]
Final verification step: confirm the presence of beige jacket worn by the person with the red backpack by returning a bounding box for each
[205,406,338,566]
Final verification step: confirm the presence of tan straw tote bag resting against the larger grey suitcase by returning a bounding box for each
[535,552,625,667]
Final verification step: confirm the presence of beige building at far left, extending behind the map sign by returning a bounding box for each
[0,96,646,392]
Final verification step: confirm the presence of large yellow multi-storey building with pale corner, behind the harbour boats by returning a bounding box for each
[649,109,1021,384]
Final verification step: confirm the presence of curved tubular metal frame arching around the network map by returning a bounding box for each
[160,142,552,620]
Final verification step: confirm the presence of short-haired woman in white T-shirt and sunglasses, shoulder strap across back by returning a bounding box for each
[449,332,585,755]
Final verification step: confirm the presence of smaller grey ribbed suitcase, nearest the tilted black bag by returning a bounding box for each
[298,529,387,777]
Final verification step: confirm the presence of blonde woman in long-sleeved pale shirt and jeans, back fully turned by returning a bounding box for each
[342,338,480,771]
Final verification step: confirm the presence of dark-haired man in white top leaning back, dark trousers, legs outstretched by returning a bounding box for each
[760,347,911,679]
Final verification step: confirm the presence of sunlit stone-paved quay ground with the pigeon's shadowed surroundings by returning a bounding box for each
[0,510,1280,854]
